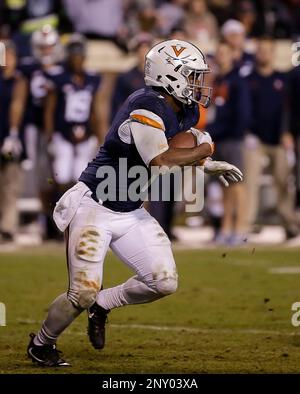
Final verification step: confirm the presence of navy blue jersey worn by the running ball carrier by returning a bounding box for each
[79,87,199,212]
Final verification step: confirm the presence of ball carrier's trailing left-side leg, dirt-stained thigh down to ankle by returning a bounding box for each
[31,197,111,364]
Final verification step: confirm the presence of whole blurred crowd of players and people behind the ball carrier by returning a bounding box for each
[0,0,300,246]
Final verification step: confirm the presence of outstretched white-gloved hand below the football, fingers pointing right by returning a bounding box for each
[204,158,243,187]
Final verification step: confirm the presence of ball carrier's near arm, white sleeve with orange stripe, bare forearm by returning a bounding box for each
[130,110,213,168]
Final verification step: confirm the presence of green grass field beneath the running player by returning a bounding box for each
[0,247,300,374]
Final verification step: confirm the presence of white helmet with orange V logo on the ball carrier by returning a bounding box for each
[145,40,212,107]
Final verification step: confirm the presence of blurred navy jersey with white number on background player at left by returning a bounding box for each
[47,67,100,143]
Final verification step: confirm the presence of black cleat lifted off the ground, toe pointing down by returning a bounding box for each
[88,302,110,349]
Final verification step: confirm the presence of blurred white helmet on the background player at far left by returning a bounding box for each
[31,25,63,65]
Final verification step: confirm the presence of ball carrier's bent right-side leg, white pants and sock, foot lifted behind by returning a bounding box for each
[97,209,178,310]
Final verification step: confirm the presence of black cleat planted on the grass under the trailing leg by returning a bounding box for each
[27,333,70,367]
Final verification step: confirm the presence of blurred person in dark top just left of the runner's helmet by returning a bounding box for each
[111,33,153,119]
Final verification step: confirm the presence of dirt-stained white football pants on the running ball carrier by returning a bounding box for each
[67,195,177,309]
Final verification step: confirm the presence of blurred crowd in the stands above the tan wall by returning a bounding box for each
[0,0,300,43]
